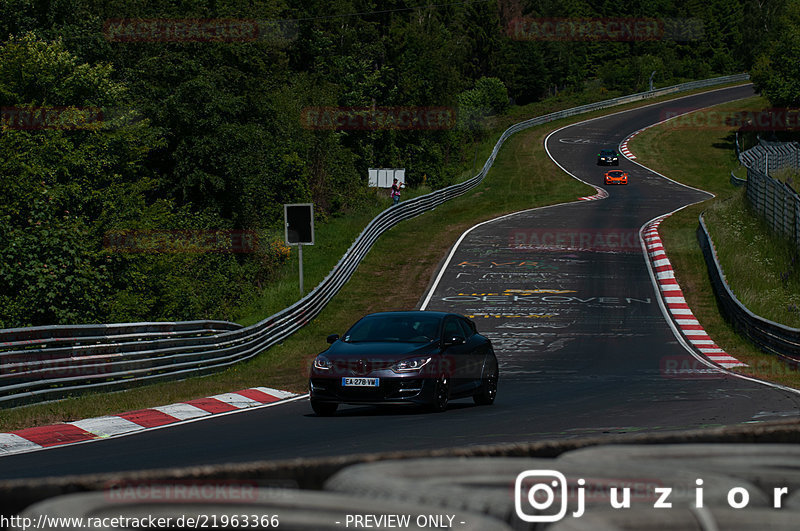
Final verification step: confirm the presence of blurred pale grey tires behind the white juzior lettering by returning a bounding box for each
[325,444,800,530]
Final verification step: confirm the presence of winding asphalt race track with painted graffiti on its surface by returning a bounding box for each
[0,86,800,479]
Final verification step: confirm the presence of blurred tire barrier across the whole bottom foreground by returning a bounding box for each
[0,420,800,529]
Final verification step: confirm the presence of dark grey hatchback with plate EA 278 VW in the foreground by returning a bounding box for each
[309,311,499,416]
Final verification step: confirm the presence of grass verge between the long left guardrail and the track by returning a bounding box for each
[0,82,752,431]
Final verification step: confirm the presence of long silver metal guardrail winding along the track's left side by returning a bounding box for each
[0,74,749,407]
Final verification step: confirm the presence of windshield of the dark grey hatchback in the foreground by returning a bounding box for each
[344,314,440,343]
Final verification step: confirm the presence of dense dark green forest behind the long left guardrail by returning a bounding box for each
[0,0,800,328]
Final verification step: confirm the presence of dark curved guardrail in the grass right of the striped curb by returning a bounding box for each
[697,214,800,363]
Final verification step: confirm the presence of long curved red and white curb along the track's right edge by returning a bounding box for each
[642,216,747,369]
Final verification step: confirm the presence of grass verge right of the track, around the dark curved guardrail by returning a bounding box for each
[630,97,800,387]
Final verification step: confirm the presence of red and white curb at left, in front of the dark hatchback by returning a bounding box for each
[0,387,298,457]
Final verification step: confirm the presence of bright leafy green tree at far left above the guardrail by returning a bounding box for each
[0,33,159,326]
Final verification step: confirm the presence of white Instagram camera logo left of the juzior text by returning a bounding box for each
[514,470,568,522]
